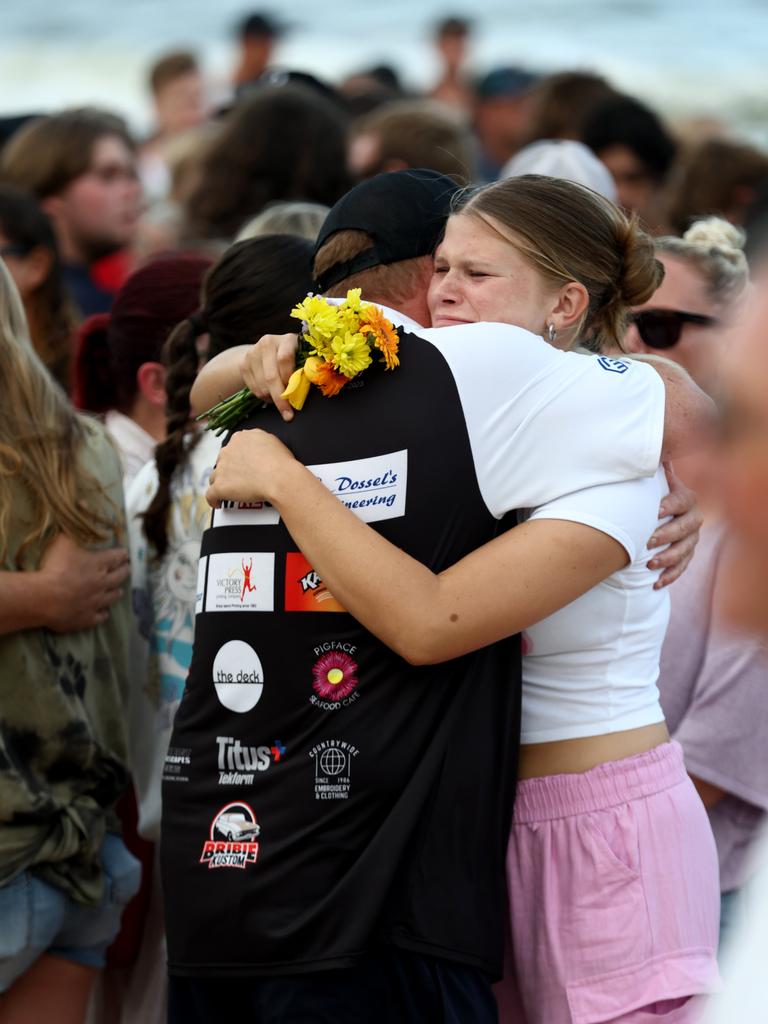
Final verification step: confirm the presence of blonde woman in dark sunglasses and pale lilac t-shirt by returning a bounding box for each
[626,217,768,950]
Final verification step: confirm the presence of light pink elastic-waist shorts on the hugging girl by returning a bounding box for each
[500,742,720,1024]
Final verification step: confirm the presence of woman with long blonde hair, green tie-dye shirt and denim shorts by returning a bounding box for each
[0,261,138,1024]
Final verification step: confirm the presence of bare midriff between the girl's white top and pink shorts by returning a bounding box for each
[518,722,670,778]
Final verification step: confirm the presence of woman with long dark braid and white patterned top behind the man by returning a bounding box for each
[115,234,312,1024]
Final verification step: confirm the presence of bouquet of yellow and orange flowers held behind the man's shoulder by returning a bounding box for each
[198,288,399,434]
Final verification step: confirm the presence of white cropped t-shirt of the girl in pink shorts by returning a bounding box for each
[521,469,670,743]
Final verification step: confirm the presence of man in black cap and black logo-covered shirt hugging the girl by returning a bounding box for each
[162,171,708,1024]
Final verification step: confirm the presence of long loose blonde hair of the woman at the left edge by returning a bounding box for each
[0,253,112,568]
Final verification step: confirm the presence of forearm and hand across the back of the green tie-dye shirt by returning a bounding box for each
[0,534,130,634]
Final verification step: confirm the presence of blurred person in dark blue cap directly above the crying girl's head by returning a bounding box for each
[474,68,539,181]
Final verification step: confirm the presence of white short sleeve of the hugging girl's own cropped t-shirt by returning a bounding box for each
[528,468,669,562]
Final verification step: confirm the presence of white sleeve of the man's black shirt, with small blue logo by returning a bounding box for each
[419,324,665,518]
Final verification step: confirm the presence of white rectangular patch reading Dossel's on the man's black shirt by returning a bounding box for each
[307,449,408,522]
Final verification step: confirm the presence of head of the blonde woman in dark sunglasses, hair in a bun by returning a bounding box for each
[624,217,746,395]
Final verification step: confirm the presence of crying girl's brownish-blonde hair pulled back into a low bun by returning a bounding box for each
[458,174,664,349]
